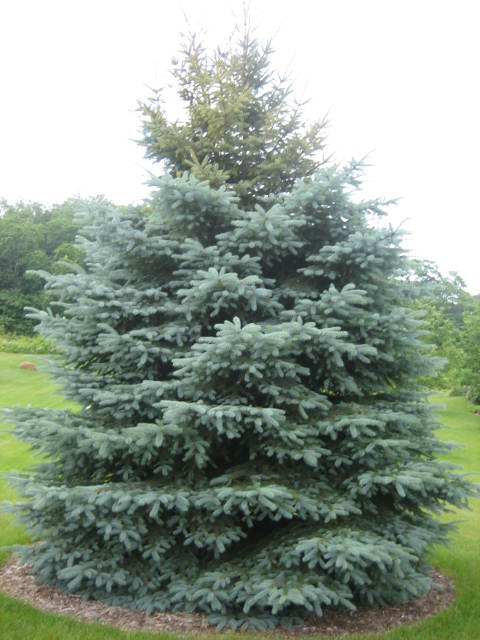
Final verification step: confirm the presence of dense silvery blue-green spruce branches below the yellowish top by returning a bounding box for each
[12,164,470,629]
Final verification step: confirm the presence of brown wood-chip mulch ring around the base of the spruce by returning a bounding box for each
[0,557,455,638]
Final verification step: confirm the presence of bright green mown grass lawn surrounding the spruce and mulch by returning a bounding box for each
[0,353,480,640]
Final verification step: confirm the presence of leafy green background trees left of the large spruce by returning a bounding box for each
[0,200,81,335]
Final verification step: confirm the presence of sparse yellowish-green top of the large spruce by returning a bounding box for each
[140,24,325,206]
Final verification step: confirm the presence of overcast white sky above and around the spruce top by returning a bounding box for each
[0,0,480,293]
